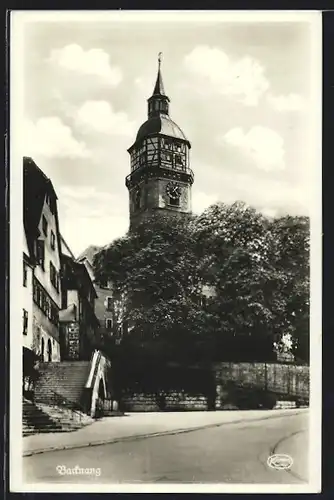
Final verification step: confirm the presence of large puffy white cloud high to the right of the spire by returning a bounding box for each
[184,45,270,106]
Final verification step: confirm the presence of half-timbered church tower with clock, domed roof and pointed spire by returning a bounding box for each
[125,53,194,228]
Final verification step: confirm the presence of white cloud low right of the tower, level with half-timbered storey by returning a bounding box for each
[222,126,285,171]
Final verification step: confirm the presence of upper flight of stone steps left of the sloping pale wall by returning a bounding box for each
[34,361,90,409]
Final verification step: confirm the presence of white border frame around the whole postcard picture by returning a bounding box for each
[9,10,322,493]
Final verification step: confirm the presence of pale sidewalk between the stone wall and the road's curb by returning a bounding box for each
[22,409,307,456]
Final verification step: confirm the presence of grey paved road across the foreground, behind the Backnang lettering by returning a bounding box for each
[23,413,308,484]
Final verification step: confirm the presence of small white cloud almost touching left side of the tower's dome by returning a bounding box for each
[75,101,135,136]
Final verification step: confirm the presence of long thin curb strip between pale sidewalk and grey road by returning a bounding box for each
[23,410,306,457]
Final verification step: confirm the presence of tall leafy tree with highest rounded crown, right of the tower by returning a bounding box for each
[197,202,277,361]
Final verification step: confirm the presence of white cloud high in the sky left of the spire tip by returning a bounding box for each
[49,44,123,86]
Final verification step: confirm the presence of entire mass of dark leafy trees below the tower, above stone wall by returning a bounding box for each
[94,202,309,368]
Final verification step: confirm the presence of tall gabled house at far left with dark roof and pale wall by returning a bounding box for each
[23,157,61,361]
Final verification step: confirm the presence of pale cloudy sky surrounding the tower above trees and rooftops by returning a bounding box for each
[16,12,320,255]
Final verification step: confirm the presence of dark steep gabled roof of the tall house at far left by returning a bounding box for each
[23,156,58,262]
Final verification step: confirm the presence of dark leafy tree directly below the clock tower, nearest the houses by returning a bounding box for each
[94,216,205,358]
